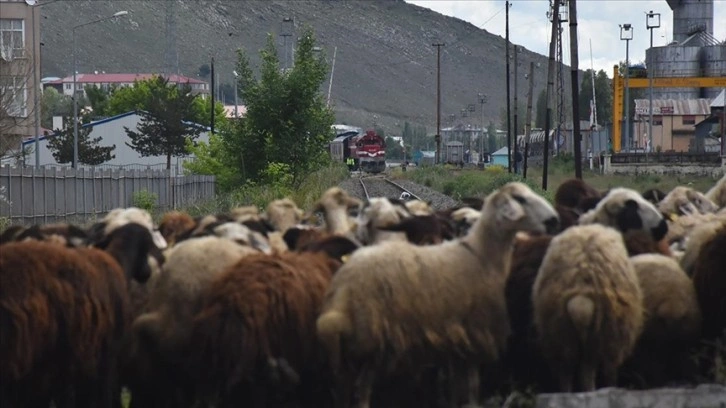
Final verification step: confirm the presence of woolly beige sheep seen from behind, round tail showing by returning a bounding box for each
[532,223,643,392]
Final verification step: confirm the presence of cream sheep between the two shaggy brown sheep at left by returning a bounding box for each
[122,228,268,406]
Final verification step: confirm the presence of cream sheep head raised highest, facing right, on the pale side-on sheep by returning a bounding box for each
[480,182,559,233]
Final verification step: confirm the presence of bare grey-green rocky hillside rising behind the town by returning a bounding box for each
[41,0,564,134]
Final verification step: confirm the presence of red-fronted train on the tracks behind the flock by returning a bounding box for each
[329,129,386,173]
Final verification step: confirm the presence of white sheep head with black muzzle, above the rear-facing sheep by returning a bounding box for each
[579,187,668,241]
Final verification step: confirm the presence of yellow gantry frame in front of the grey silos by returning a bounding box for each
[613,65,726,152]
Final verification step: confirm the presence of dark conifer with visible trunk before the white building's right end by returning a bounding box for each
[124,76,203,169]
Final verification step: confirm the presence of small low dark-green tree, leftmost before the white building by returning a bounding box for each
[48,115,116,166]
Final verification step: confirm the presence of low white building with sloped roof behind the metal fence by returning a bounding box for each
[18,112,209,174]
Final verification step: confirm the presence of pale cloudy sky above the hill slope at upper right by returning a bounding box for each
[406,0,726,77]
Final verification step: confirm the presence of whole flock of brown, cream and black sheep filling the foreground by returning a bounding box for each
[0,177,726,408]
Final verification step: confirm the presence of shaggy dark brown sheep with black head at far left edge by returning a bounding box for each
[0,223,159,408]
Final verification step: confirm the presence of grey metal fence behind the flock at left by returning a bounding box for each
[0,166,215,224]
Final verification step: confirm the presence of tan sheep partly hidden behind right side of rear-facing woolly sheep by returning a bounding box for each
[621,253,701,387]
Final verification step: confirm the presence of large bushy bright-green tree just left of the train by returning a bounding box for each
[224,27,334,184]
